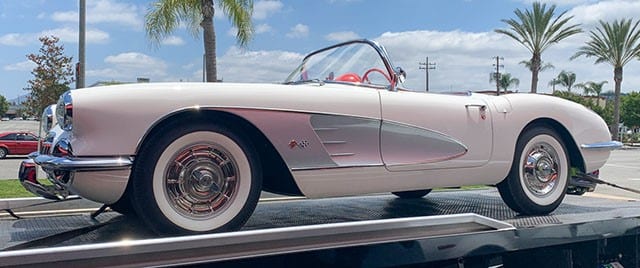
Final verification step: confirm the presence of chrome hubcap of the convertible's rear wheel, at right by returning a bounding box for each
[523,142,561,196]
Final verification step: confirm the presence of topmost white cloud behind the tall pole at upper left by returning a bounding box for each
[51,0,143,29]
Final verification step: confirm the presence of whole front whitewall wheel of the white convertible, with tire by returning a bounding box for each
[132,124,262,234]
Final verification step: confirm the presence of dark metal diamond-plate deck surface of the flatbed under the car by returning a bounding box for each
[0,189,640,250]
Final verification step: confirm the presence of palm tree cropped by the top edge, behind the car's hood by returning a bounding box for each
[145,0,253,82]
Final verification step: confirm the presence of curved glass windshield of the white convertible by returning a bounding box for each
[285,42,392,87]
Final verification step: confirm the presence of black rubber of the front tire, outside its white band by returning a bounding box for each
[131,123,262,234]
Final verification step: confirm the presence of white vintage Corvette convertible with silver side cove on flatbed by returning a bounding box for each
[23,40,620,233]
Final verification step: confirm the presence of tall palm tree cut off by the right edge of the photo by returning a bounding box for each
[571,19,640,140]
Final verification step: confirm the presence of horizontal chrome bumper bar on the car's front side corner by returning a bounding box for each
[29,152,133,171]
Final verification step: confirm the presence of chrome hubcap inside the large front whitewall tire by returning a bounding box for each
[164,144,240,219]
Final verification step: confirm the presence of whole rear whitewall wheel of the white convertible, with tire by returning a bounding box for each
[498,127,570,215]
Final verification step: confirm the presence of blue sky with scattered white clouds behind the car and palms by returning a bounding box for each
[0,0,640,99]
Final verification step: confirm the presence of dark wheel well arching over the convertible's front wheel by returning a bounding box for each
[136,110,302,195]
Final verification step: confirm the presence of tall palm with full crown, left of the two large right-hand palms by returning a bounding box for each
[495,2,582,93]
